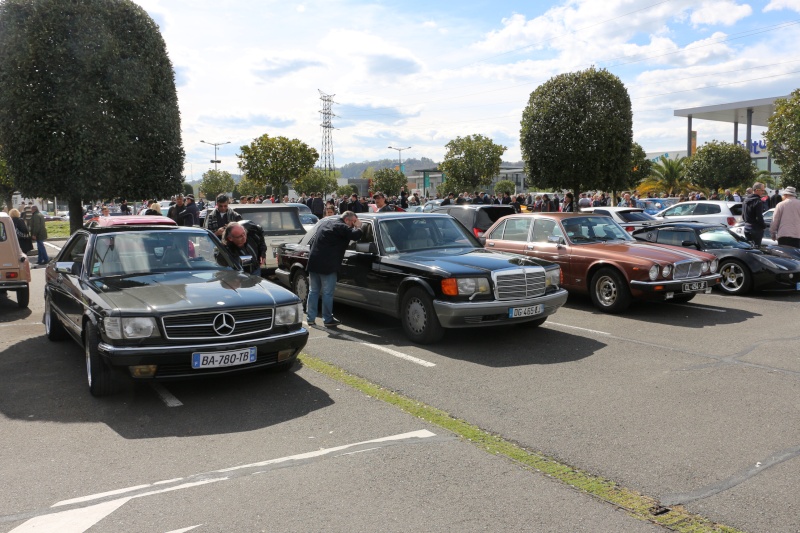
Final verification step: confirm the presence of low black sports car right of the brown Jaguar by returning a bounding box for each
[633,222,800,294]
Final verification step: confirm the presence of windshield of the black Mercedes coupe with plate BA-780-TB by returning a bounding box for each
[91,231,237,277]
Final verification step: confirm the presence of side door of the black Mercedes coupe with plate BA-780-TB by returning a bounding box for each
[48,232,89,333]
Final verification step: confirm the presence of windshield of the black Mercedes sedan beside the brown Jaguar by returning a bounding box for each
[379,216,483,254]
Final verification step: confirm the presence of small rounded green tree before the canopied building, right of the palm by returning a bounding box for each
[685,141,756,191]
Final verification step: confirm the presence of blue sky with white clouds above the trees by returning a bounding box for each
[135,0,800,180]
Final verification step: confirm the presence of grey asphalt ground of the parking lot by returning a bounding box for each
[0,256,800,532]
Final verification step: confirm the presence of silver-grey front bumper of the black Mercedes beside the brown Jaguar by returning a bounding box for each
[433,289,567,328]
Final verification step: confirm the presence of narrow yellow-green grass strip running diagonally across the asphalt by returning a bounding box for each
[300,354,741,533]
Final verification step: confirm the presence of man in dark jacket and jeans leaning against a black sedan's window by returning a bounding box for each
[306,211,361,328]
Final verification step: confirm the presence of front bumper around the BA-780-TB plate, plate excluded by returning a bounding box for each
[99,327,308,379]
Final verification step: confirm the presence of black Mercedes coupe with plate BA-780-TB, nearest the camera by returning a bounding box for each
[43,221,308,396]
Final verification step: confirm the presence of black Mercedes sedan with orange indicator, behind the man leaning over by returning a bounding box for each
[275,213,567,344]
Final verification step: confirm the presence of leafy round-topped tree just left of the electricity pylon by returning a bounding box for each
[239,134,319,194]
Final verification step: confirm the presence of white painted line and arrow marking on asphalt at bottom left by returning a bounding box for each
[10,429,436,533]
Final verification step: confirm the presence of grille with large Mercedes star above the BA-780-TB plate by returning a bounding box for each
[162,308,273,339]
